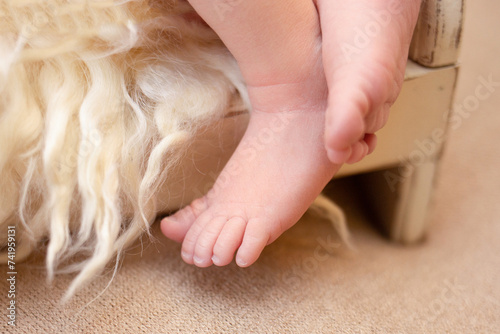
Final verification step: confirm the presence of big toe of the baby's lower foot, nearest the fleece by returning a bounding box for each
[160,197,207,242]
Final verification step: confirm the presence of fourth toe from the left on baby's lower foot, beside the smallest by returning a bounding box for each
[212,217,247,266]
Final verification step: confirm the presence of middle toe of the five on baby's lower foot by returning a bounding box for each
[193,217,228,268]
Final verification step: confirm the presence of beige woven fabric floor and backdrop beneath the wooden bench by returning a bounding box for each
[0,0,500,333]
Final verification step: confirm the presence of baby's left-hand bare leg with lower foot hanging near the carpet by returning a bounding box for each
[162,0,339,267]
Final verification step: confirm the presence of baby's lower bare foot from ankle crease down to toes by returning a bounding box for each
[161,79,339,267]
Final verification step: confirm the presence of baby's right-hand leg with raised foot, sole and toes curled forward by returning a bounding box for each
[317,0,420,163]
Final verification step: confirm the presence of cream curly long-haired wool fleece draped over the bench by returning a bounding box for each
[0,0,246,297]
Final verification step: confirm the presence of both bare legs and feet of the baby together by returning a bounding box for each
[162,0,420,266]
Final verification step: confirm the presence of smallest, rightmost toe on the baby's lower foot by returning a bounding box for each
[236,222,269,267]
